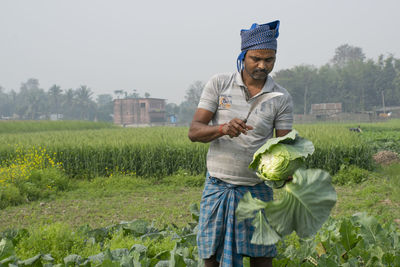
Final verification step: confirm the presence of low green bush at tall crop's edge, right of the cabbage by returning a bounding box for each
[332,165,371,185]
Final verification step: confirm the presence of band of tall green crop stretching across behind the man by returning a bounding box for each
[0,121,398,177]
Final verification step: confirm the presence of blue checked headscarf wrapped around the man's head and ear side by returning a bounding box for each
[237,20,280,72]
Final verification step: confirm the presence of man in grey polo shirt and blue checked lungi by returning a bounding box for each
[188,21,293,267]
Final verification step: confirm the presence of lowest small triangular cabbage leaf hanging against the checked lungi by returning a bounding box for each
[250,210,281,245]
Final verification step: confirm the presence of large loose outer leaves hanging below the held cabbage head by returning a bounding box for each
[236,168,337,245]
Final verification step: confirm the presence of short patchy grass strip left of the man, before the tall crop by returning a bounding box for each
[0,174,204,232]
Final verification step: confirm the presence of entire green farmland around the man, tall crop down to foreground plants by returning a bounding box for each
[0,120,400,266]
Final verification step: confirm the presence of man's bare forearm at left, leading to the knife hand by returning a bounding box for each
[188,121,223,143]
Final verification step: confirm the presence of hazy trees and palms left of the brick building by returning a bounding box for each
[0,78,113,121]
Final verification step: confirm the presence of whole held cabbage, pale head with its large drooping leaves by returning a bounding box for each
[236,130,337,245]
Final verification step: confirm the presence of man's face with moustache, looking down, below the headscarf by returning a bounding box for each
[244,49,276,80]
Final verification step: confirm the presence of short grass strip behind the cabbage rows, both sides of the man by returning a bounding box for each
[0,164,400,231]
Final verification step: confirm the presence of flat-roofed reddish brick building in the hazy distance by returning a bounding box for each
[114,98,166,126]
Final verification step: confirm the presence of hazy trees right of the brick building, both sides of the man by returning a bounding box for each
[173,44,400,123]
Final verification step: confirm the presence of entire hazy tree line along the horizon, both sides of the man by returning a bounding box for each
[0,44,400,124]
